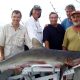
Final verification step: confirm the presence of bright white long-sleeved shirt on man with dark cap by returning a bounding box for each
[25,16,43,44]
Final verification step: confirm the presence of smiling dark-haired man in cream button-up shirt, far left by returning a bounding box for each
[0,10,32,60]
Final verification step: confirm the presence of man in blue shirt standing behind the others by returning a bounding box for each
[61,4,75,30]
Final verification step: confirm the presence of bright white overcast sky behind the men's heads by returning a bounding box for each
[0,0,80,29]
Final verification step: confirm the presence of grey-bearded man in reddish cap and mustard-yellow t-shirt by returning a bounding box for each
[63,11,80,51]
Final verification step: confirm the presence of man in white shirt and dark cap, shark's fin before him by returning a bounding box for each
[25,5,43,47]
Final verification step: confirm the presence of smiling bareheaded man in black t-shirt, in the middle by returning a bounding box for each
[43,12,64,50]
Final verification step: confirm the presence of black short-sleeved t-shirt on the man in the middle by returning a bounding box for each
[43,24,64,50]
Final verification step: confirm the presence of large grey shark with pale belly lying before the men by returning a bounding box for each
[0,48,80,71]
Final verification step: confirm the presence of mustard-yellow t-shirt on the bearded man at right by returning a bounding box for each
[63,26,80,51]
